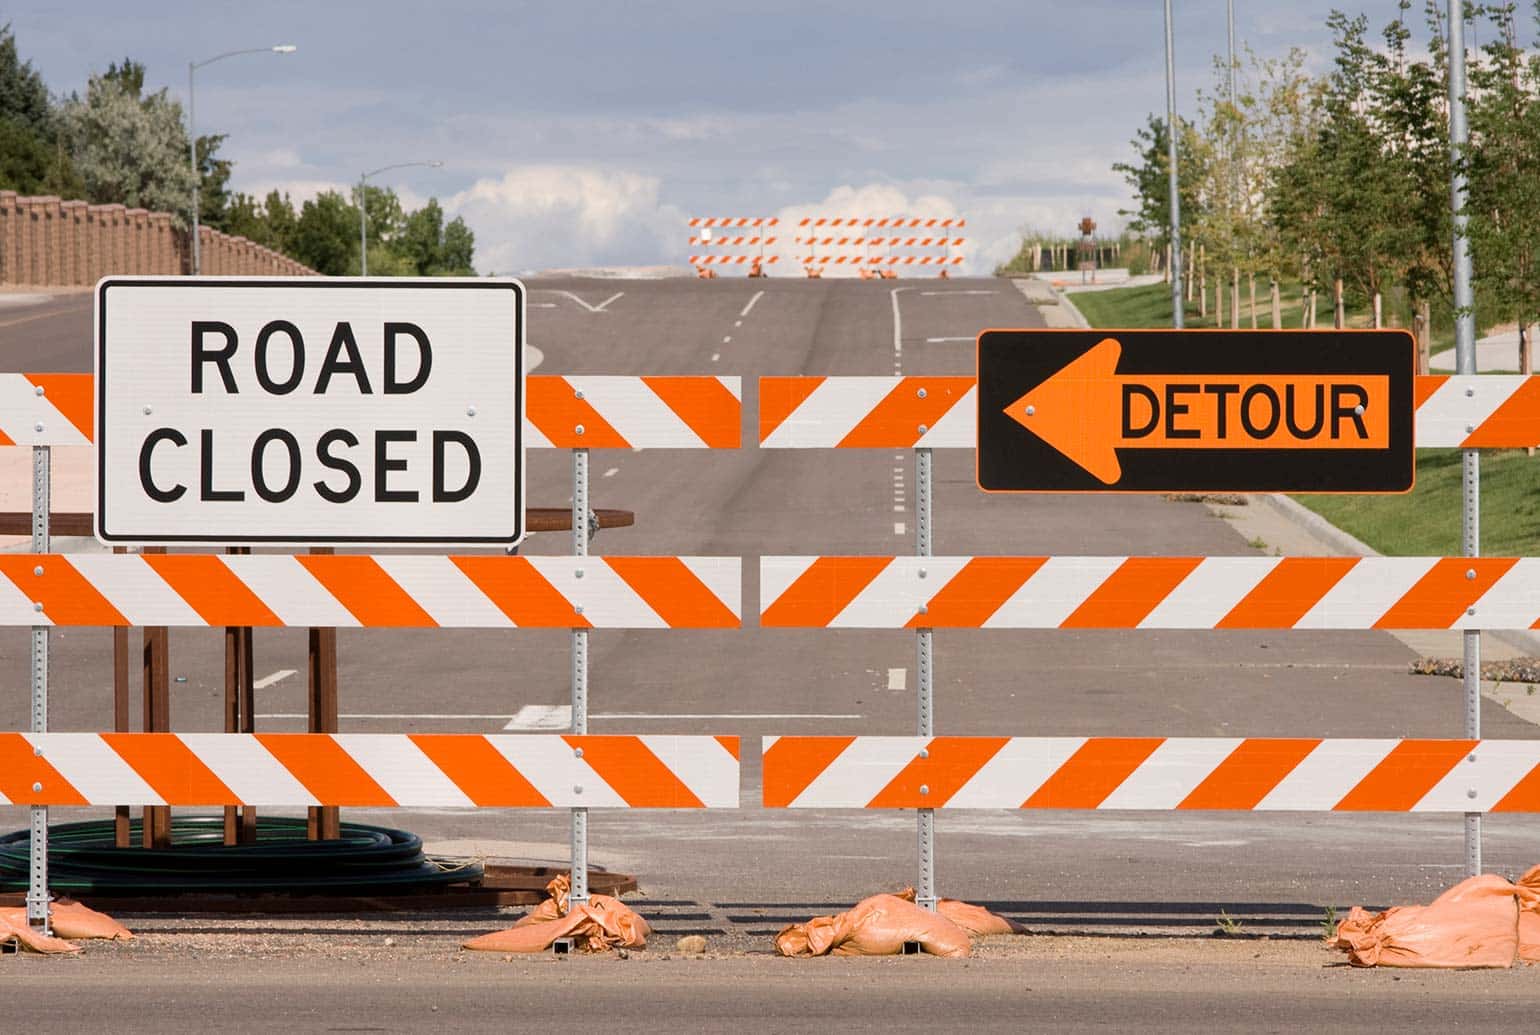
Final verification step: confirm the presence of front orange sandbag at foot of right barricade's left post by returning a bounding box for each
[775,895,969,956]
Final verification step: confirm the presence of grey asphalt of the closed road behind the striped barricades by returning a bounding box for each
[0,279,1540,1027]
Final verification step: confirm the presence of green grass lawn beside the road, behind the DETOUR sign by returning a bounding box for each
[1070,283,1540,558]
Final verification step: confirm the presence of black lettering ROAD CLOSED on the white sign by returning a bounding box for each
[137,320,482,504]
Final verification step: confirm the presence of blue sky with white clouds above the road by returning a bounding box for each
[0,0,1420,273]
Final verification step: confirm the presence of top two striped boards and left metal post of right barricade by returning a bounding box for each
[759,376,1540,904]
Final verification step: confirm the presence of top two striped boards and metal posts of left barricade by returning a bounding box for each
[0,374,742,926]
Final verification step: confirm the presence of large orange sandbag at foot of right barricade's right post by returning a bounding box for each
[1331,873,1518,967]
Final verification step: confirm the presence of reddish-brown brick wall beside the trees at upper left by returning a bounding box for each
[0,191,316,286]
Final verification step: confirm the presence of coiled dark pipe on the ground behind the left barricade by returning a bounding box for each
[0,816,484,895]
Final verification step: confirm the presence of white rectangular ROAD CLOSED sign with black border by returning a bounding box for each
[95,277,525,547]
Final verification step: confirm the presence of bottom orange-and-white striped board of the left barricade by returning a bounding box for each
[0,733,739,809]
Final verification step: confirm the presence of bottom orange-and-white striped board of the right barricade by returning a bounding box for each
[762,736,1540,813]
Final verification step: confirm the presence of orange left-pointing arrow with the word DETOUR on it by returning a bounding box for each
[1006,337,1391,485]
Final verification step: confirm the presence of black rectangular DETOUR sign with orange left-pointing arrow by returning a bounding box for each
[978,330,1415,493]
